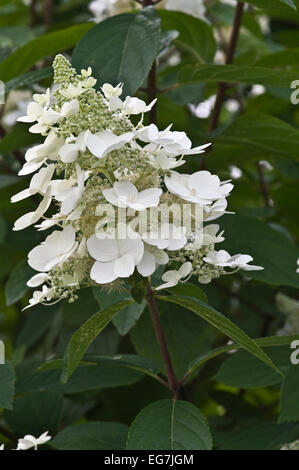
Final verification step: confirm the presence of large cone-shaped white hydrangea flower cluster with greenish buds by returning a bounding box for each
[12,55,262,308]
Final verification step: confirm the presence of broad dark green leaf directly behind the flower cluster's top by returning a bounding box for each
[72,7,161,97]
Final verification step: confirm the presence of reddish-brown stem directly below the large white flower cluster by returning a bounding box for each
[146,282,179,399]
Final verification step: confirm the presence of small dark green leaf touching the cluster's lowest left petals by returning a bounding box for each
[5,259,34,306]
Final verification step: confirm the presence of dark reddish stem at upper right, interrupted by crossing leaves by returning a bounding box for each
[201,2,244,169]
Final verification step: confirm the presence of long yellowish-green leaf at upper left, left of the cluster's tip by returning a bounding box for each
[0,23,93,82]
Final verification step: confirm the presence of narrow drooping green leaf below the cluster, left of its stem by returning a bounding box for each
[62,300,134,382]
